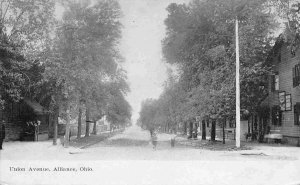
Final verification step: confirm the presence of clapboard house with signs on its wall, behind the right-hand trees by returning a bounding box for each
[251,36,300,145]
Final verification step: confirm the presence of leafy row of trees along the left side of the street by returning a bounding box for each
[0,0,131,147]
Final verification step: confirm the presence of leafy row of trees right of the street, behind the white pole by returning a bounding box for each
[139,0,295,140]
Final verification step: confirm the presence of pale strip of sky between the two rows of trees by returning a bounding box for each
[120,0,188,123]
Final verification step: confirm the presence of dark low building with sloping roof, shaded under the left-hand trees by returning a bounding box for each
[0,98,50,141]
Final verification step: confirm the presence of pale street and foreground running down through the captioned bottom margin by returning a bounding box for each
[0,126,300,185]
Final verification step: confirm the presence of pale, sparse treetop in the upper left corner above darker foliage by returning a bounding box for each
[0,0,55,56]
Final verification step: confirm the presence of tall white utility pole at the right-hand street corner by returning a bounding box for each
[235,16,241,148]
